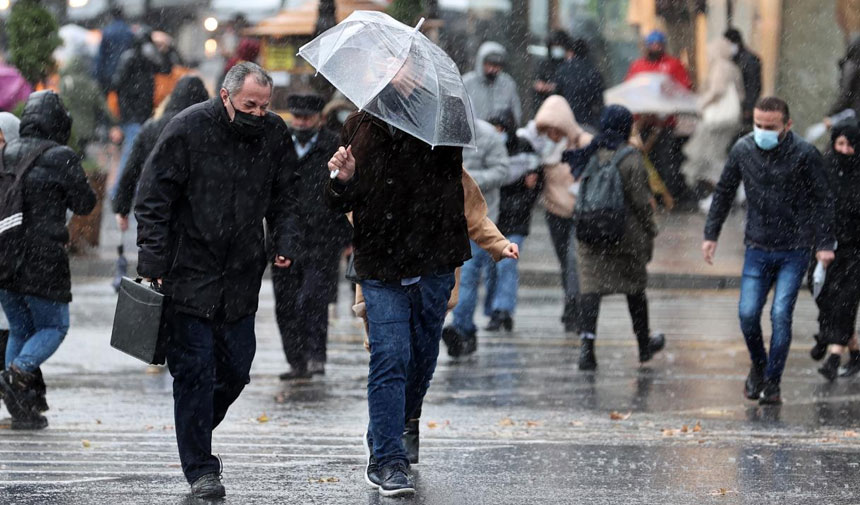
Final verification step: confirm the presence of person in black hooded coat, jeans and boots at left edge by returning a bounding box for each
[0,91,96,429]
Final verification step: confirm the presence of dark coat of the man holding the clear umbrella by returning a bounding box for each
[326,113,471,282]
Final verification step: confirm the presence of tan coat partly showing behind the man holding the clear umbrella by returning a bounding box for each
[352,170,511,324]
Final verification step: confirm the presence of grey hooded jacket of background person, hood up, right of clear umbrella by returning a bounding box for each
[463,41,522,124]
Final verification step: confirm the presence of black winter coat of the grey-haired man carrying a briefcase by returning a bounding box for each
[135,97,299,321]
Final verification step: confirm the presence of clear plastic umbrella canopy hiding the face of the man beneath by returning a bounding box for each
[299,11,475,147]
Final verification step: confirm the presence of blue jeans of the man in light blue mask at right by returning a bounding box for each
[739,247,810,382]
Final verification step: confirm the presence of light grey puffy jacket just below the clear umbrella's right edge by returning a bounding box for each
[463,119,509,222]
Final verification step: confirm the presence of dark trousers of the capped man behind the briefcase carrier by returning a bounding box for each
[272,260,337,368]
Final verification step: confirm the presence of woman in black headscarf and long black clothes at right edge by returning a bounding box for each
[816,124,860,381]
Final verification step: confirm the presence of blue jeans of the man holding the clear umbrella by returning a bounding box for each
[361,273,454,468]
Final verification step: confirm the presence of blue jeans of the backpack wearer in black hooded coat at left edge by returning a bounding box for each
[0,289,69,373]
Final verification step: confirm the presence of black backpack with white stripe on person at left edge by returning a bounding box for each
[0,141,57,279]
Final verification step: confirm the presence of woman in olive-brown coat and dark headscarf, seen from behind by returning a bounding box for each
[565,105,665,370]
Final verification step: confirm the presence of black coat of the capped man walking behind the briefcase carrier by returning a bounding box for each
[294,129,352,268]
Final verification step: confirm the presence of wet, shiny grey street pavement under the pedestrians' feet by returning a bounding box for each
[0,280,860,505]
